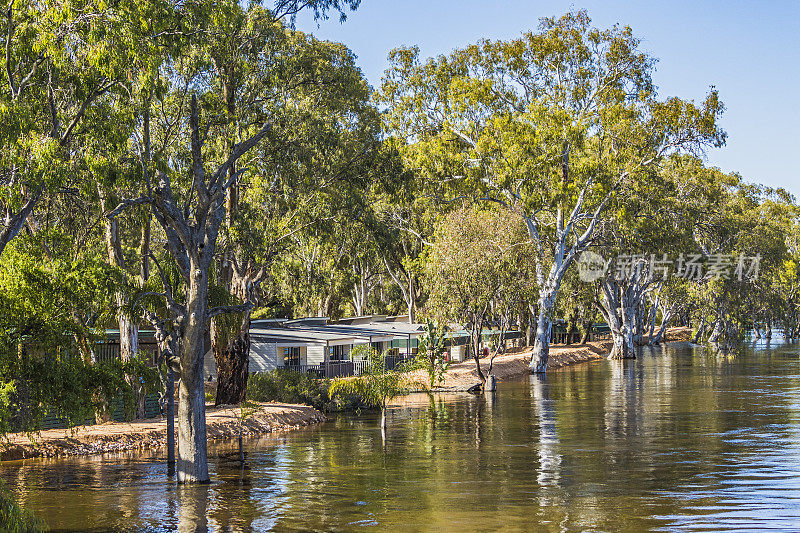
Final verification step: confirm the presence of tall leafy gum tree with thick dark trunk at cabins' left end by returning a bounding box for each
[205,15,381,403]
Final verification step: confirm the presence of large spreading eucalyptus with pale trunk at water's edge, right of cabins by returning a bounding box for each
[380,12,725,372]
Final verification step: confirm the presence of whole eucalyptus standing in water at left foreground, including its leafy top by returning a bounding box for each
[108,2,360,482]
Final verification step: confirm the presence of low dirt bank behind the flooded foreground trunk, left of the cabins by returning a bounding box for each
[0,403,325,461]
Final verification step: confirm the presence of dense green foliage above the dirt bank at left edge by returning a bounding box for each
[0,244,158,434]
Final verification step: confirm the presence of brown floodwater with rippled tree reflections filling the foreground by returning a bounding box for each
[0,338,800,532]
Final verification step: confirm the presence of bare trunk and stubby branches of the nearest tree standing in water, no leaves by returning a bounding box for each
[112,94,272,483]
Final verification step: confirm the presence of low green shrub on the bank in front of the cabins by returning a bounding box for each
[247,368,331,411]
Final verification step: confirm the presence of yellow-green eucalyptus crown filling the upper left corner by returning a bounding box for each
[0,0,146,254]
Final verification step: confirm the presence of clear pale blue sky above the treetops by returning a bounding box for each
[297,0,800,198]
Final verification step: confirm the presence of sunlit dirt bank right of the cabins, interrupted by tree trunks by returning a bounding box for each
[412,328,691,391]
